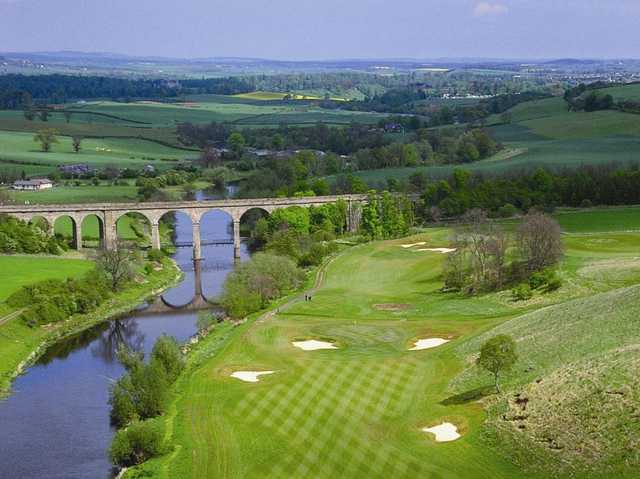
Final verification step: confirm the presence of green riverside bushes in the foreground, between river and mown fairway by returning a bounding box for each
[109,336,184,467]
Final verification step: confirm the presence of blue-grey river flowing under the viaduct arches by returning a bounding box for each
[0,190,248,479]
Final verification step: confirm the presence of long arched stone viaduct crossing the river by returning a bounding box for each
[0,195,367,260]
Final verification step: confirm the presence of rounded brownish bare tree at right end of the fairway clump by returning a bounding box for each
[518,211,563,272]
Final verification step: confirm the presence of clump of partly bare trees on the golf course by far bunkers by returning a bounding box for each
[444,209,563,299]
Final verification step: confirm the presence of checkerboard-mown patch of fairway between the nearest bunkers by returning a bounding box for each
[236,358,428,478]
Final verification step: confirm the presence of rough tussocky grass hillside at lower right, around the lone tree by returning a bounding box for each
[453,286,640,478]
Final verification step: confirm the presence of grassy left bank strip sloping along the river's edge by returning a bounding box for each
[0,258,183,397]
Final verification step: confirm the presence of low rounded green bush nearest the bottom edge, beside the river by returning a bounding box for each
[109,420,166,467]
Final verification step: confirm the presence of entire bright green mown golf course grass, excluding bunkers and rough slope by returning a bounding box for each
[138,208,640,478]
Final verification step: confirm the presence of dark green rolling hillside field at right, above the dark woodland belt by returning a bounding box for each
[344,85,640,183]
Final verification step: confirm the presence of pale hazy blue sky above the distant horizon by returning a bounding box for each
[0,0,640,60]
